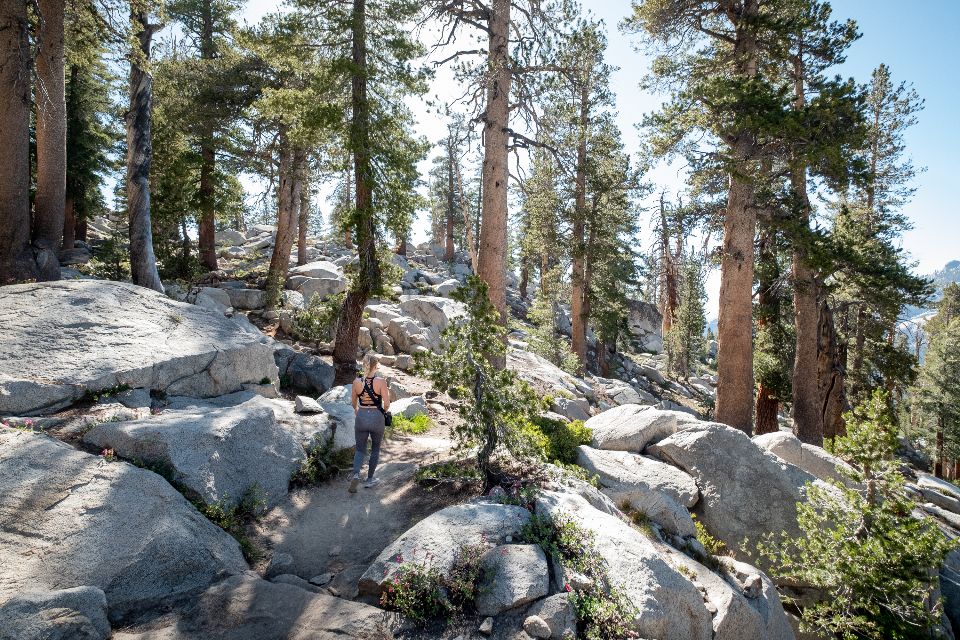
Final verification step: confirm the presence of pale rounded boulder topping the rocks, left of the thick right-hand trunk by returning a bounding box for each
[586,404,704,453]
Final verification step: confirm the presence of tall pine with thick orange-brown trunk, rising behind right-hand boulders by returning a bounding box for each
[625,0,786,433]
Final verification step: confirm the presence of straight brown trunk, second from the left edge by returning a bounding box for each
[33,0,67,280]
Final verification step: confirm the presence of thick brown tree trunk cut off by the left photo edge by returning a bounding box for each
[0,0,37,285]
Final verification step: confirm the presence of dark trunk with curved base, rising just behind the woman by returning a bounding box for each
[333,0,381,384]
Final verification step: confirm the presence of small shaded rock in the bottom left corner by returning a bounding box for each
[0,587,110,640]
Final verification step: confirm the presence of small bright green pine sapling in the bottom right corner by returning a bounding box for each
[758,391,953,640]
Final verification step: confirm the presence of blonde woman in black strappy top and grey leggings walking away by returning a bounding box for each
[350,353,390,493]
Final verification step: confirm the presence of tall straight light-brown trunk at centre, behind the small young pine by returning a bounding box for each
[477,0,512,330]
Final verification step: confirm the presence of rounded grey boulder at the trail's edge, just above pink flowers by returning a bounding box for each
[359,503,528,593]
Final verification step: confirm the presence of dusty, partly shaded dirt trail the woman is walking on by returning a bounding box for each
[256,427,462,599]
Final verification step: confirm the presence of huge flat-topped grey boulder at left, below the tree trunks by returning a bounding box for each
[0,280,277,415]
